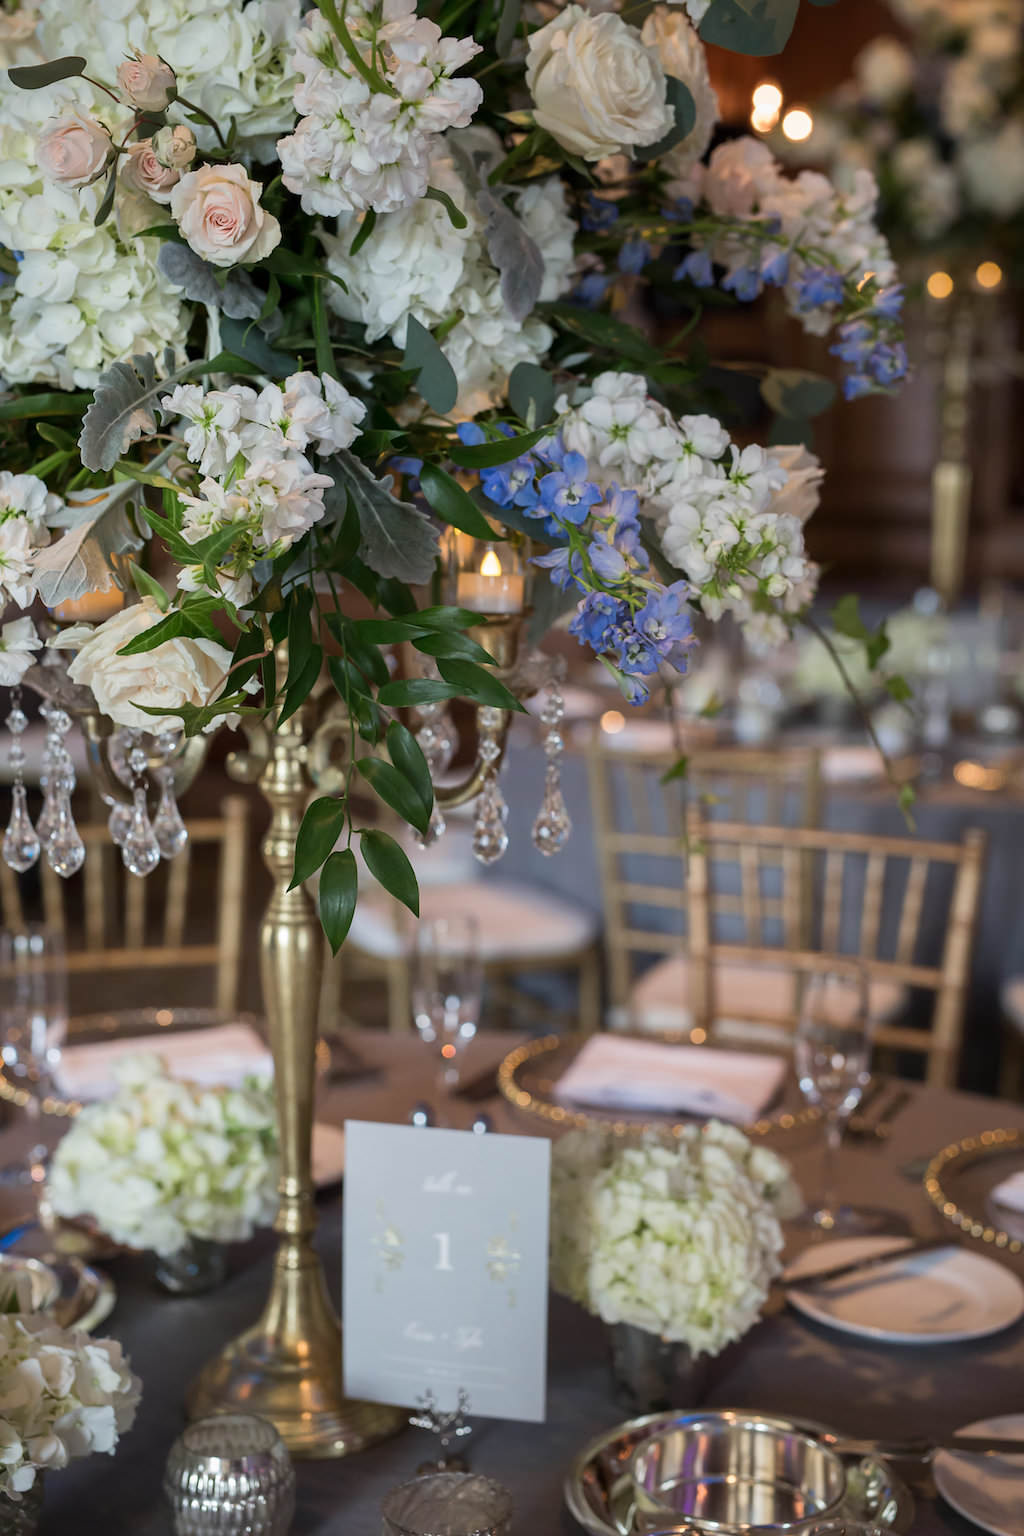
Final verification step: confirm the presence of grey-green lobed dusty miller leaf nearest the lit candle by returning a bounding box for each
[324,449,439,584]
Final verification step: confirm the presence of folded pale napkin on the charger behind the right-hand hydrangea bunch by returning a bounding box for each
[556,1035,788,1124]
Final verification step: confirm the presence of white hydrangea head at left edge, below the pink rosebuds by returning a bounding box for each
[0,80,187,389]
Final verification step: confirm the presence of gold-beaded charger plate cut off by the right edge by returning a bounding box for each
[924,1130,1024,1255]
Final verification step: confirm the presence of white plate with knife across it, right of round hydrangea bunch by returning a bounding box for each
[786,1236,1024,1345]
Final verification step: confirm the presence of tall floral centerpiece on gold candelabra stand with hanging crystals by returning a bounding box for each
[0,0,906,1455]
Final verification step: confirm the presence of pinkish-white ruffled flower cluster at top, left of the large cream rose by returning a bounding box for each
[278,0,484,215]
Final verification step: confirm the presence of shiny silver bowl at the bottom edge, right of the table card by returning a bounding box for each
[631,1413,846,1533]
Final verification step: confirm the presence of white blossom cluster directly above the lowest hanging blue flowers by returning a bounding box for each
[557,373,823,645]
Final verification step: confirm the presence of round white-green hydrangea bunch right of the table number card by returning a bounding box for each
[551,1120,801,1356]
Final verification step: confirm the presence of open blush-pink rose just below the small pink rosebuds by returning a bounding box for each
[170,166,281,267]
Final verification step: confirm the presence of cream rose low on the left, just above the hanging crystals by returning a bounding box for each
[68,598,232,731]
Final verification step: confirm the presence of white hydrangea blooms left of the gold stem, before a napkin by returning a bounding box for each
[49,1052,278,1256]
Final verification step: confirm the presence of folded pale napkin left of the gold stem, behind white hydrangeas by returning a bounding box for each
[54,1025,273,1100]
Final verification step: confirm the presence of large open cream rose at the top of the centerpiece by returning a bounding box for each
[527,5,672,160]
